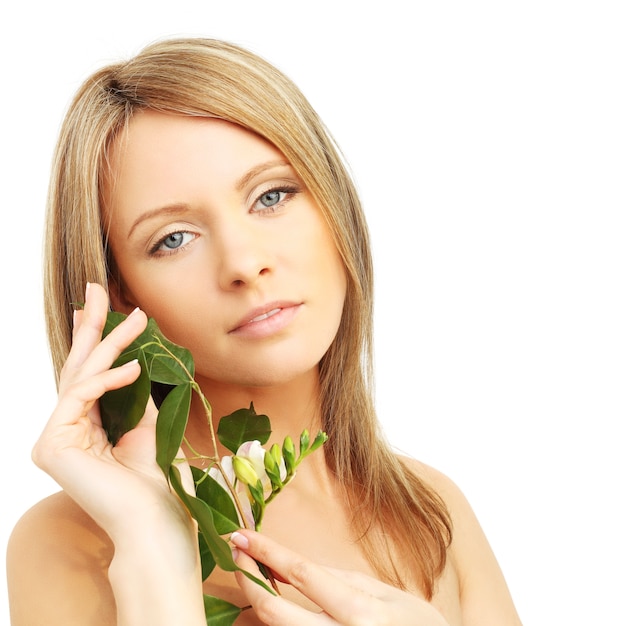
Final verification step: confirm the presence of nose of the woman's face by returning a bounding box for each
[214,220,272,290]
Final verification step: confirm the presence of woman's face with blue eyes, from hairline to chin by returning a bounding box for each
[103,112,346,386]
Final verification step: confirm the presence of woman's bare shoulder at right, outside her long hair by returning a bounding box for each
[394,457,521,626]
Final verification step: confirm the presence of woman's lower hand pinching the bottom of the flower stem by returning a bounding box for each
[231,530,447,626]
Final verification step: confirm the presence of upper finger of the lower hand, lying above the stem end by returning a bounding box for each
[231,530,380,624]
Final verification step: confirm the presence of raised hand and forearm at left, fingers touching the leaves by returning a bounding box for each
[33,284,206,626]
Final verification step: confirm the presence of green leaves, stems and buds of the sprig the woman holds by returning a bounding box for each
[100,313,326,626]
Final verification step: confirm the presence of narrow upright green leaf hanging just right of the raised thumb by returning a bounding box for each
[156,383,191,476]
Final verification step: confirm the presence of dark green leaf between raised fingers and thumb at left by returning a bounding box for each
[99,354,150,445]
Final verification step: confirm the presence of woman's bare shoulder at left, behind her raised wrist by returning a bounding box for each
[6,492,115,626]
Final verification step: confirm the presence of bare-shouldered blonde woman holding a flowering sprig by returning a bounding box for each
[7,40,519,626]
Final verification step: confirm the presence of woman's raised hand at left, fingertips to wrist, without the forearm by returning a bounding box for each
[33,284,176,541]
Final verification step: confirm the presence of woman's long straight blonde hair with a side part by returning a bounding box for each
[44,39,451,597]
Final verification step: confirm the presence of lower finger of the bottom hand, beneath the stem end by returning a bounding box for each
[235,551,337,626]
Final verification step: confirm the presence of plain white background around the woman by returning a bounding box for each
[0,0,626,626]
